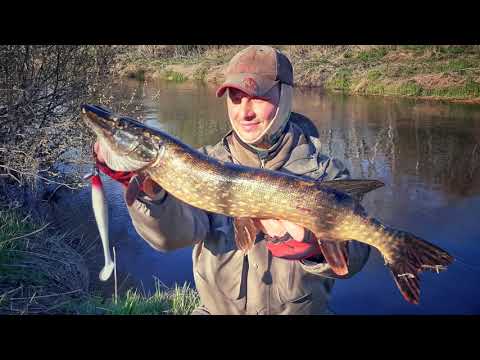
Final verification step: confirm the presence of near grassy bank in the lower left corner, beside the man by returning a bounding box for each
[0,206,199,315]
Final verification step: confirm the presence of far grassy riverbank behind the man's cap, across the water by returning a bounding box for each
[115,45,480,103]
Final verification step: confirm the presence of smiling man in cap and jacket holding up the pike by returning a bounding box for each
[97,46,370,314]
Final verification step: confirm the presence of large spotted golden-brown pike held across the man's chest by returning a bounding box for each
[82,105,453,304]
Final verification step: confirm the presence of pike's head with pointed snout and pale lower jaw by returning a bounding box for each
[81,105,164,171]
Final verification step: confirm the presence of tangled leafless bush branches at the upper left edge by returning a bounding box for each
[0,45,122,188]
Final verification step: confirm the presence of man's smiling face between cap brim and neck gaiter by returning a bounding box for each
[227,85,280,142]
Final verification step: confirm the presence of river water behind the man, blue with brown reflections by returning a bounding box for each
[49,80,480,314]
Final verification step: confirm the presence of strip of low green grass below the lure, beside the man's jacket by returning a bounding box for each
[65,280,200,315]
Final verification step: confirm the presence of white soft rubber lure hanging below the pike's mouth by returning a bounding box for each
[90,169,115,281]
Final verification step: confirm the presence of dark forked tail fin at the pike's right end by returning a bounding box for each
[387,231,453,304]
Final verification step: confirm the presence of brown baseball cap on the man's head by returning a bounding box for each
[217,45,293,97]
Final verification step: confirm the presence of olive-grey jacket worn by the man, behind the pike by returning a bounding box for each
[129,114,370,314]
